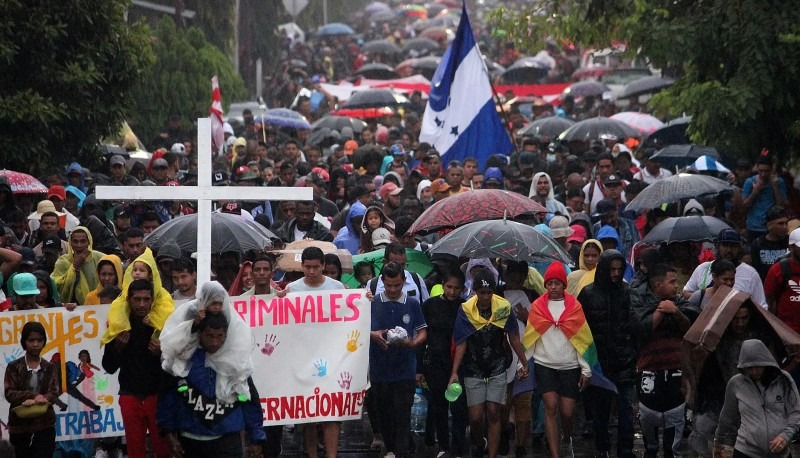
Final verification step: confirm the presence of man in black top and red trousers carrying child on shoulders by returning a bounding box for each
[103,280,170,458]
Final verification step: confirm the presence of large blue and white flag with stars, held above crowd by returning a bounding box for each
[419,7,514,169]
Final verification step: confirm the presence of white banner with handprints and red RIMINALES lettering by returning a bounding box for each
[230,289,371,426]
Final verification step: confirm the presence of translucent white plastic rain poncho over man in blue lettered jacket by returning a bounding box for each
[160,281,253,403]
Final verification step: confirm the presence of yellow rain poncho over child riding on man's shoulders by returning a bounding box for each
[100,248,175,345]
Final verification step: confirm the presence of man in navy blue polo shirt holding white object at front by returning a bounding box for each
[369,262,428,458]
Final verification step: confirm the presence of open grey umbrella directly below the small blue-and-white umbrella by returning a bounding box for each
[625,173,735,212]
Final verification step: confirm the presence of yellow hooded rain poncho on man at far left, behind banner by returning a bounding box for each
[50,226,105,304]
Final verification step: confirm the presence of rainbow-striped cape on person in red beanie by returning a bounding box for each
[522,293,617,393]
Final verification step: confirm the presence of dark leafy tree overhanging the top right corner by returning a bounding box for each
[494,0,800,161]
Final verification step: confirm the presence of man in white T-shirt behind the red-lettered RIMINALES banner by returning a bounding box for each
[283,247,344,458]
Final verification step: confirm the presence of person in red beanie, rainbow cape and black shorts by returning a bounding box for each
[522,262,599,458]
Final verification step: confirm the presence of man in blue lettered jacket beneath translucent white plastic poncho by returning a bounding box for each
[158,314,265,458]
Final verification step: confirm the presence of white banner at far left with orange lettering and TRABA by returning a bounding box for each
[0,305,125,441]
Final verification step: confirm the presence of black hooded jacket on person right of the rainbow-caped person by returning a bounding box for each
[578,250,636,383]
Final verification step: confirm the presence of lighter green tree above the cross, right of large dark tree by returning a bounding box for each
[128,17,246,144]
